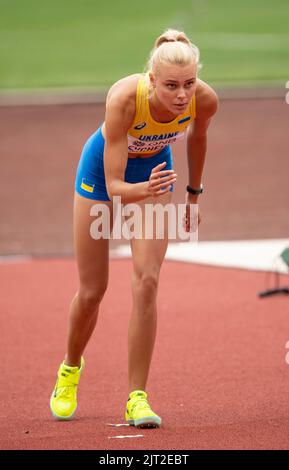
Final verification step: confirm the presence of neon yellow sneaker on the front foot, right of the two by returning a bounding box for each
[125,390,162,428]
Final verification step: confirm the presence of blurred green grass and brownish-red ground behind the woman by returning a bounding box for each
[0,0,289,256]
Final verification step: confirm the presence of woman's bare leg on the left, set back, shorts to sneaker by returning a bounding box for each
[65,193,112,366]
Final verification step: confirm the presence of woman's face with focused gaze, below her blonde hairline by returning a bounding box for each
[150,62,197,115]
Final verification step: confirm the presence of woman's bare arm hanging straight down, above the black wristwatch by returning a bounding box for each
[187,80,218,202]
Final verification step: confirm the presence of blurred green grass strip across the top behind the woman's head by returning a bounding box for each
[0,0,289,89]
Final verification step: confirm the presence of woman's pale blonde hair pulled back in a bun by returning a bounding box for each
[146,29,202,73]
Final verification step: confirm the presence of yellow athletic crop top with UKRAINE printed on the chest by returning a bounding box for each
[127,74,196,155]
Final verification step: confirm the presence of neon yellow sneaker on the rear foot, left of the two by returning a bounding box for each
[50,357,84,420]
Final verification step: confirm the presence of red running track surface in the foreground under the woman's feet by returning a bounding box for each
[0,259,289,450]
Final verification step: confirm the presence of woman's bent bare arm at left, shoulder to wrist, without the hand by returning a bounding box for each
[104,91,149,203]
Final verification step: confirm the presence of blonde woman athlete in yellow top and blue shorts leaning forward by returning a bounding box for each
[50,29,218,427]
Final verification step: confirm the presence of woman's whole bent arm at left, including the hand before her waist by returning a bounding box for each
[104,86,176,203]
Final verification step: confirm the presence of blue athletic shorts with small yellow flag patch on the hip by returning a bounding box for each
[75,127,173,201]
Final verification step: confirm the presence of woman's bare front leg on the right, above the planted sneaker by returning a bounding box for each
[128,192,172,391]
